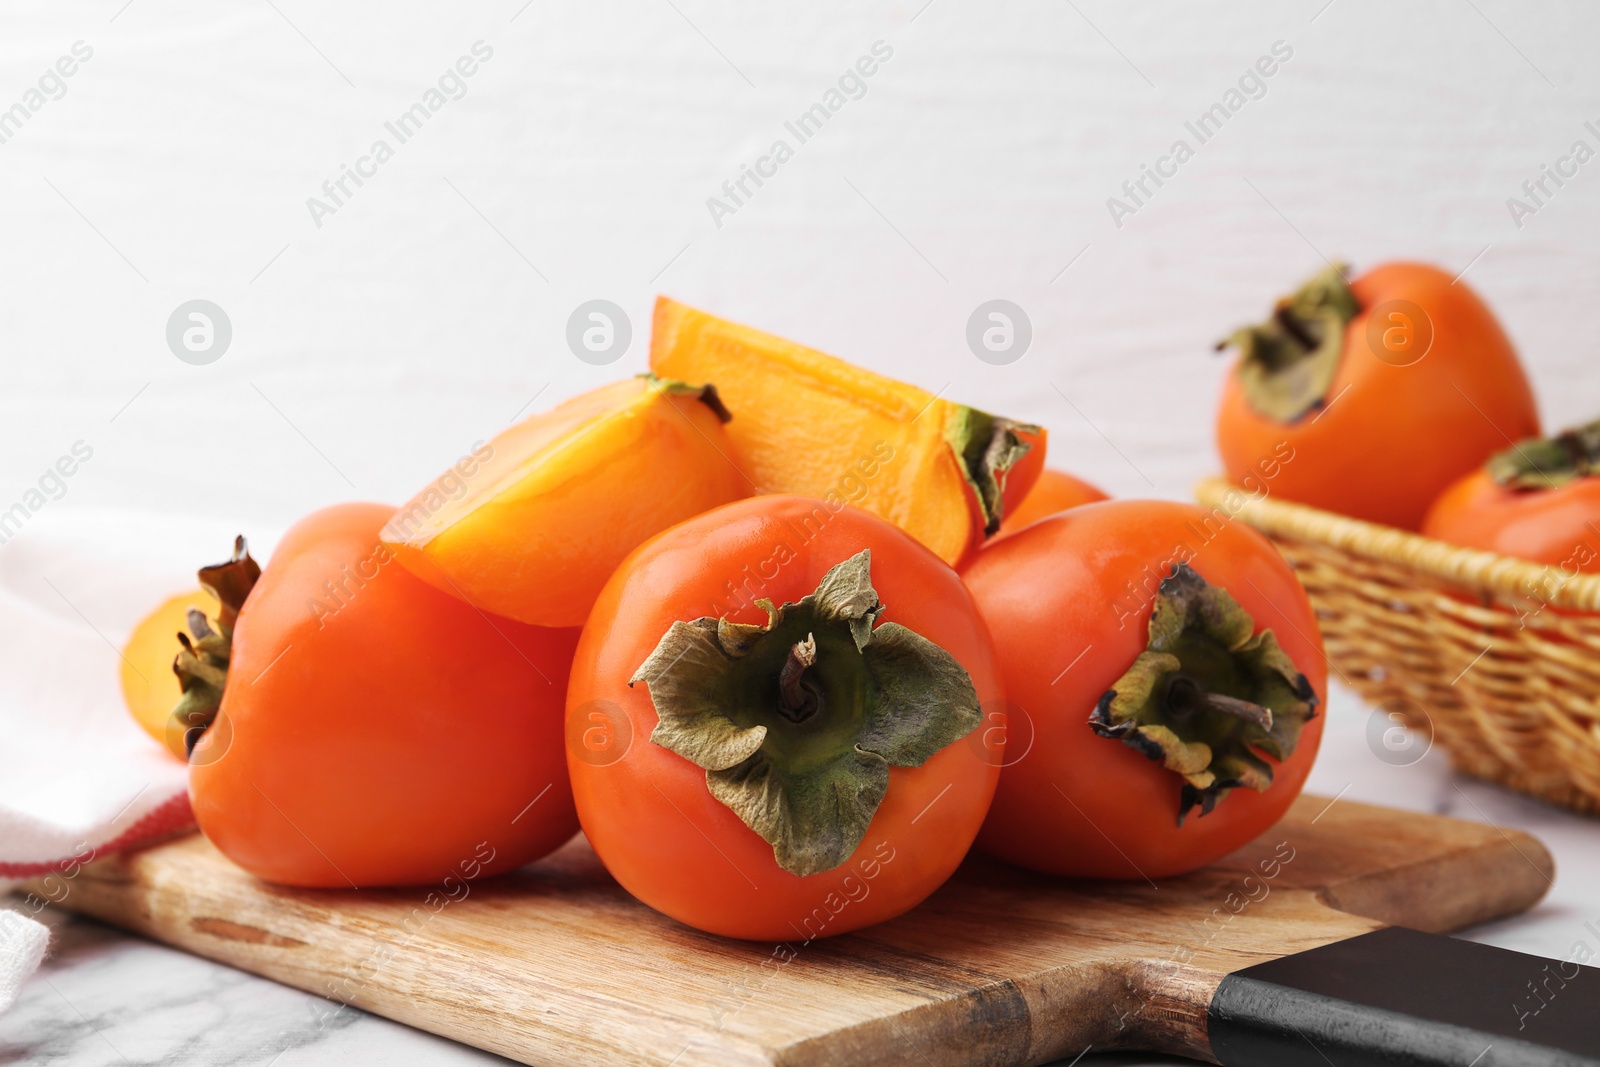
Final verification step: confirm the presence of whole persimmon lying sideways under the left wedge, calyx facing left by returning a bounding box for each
[188,504,578,889]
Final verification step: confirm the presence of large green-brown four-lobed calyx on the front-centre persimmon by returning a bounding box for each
[629,550,982,877]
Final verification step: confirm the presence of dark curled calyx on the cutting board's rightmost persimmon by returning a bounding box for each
[1090,563,1317,825]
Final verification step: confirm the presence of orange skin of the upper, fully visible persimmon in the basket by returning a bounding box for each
[1216,262,1539,530]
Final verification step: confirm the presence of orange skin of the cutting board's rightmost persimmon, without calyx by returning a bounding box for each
[963,501,1328,880]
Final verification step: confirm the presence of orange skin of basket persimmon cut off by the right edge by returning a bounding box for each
[1422,470,1600,574]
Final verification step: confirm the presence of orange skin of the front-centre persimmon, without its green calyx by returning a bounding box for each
[566,496,1003,944]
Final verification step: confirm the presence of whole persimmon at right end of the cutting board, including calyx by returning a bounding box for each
[963,501,1328,878]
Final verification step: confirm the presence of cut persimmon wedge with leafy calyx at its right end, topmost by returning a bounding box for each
[650,298,1045,566]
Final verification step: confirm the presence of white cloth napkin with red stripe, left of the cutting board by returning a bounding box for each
[0,504,277,1011]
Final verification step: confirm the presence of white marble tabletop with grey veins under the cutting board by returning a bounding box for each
[0,693,1600,1067]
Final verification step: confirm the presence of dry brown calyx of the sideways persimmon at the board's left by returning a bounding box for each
[173,536,261,753]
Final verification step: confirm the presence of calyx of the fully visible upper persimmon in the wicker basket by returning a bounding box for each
[1216,264,1360,422]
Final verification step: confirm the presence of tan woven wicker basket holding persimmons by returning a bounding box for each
[1195,478,1600,814]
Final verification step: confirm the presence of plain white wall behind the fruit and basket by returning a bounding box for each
[0,0,1600,536]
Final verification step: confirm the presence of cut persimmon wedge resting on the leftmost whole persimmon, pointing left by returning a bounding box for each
[382,376,750,627]
